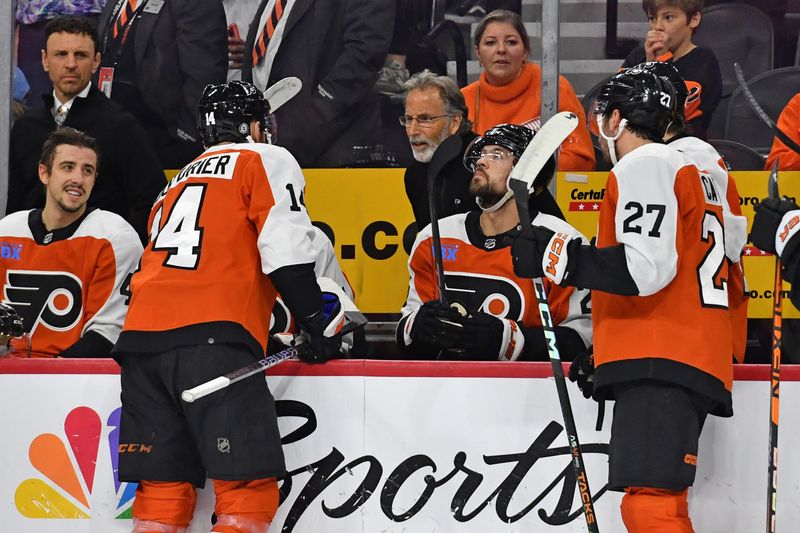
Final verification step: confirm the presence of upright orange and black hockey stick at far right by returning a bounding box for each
[767,159,783,533]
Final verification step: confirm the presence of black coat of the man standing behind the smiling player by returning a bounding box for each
[6,86,166,242]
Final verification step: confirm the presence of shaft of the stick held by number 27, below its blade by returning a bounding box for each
[509,178,600,533]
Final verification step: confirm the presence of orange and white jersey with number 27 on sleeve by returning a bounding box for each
[592,144,733,415]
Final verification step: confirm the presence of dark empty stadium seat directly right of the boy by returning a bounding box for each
[692,4,774,97]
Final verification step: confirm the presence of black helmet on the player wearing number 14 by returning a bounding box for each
[197,80,269,146]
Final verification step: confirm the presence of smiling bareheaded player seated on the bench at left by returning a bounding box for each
[0,127,142,357]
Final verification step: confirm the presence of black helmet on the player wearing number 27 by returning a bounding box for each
[592,68,676,142]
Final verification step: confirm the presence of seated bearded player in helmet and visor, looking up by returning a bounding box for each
[396,124,591,361]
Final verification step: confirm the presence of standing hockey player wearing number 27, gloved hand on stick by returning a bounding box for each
[512,69,733,533]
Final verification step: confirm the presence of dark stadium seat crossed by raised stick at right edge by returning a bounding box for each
[724,67,800,154]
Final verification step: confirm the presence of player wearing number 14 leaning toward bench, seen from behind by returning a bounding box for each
[113,81,341,533]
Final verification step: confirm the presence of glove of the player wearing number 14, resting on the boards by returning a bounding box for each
[298,292,345,363]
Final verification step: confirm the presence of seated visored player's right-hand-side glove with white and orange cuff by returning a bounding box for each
[456,311,525,361]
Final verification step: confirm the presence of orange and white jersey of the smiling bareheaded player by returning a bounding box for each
[0,209,142,357]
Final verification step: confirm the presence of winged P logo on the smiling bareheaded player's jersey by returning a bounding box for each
[3,270,83,334]
